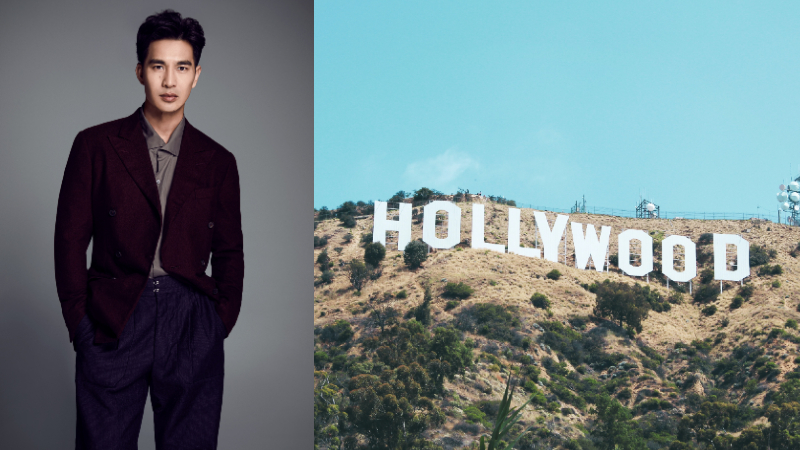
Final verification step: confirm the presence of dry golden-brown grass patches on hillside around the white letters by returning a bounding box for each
[314,203,800,432]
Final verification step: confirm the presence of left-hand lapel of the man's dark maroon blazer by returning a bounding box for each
[108,108,162,221]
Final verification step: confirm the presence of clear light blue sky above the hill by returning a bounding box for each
[314,1,800,218]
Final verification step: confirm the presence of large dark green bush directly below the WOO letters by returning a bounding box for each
[594,280,650,333]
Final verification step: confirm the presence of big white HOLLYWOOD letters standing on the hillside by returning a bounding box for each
[372,200,750,282]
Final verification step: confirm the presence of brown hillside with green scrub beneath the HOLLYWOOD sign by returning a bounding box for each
[314,200,800,449]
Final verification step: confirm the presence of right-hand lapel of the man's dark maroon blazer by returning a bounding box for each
[164,120,215,227]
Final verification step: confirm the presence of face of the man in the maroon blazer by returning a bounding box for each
[136,39,200,115]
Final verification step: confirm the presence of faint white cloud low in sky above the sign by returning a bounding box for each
[403,148,480,194]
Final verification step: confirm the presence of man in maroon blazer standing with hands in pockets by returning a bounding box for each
[55,10,244,449]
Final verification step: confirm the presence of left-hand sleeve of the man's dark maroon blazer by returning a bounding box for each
[54,131,93,342]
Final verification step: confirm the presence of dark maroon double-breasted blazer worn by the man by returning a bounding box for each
[55,110,244,343]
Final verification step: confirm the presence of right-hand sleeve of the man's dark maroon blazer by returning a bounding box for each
[211,155,244,337]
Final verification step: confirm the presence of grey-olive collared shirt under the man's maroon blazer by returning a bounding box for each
[139,107,186,278]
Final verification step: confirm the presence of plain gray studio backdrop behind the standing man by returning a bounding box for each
[0,0,314,450]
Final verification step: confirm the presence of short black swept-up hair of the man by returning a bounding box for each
[136,9,206,67]
